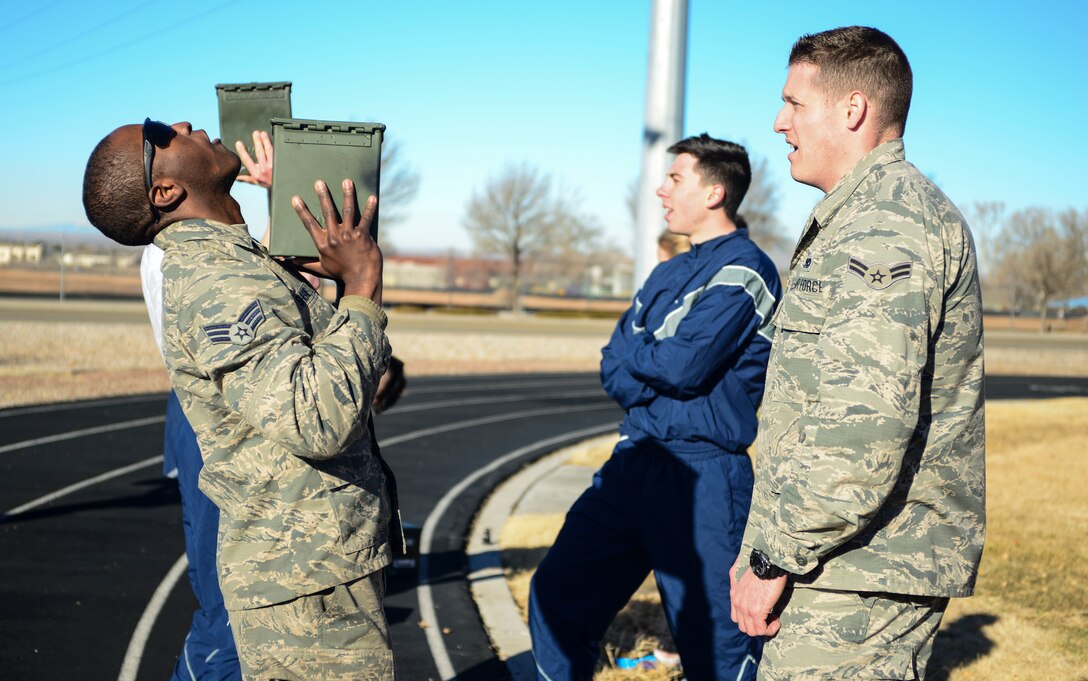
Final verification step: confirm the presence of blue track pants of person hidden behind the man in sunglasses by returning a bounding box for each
[163,392,242,681]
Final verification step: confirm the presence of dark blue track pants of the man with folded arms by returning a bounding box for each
[529,439,763,681]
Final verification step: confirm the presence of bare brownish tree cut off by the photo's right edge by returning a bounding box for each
[1000,208,1088,331]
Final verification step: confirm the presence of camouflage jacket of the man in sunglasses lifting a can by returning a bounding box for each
[154,220,391,610]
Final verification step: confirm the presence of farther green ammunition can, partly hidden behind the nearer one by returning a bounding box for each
[215,83,290,174]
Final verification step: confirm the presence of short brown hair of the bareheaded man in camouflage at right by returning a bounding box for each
[790,26,914,136]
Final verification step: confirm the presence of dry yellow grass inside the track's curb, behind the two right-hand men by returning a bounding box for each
[502,398,1088,681]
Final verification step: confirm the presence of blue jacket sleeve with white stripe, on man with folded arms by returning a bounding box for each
[623,265,776,399]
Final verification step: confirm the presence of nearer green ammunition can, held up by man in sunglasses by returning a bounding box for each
[269,119,385,257]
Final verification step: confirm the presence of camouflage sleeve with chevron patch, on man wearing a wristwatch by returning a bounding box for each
[746,225,932,574]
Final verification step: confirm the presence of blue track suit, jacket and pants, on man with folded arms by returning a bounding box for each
[529,230,781,681]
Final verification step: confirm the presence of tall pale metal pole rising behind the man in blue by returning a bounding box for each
[634,0,688,288]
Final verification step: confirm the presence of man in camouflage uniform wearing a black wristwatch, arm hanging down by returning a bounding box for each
[731,27,986,679]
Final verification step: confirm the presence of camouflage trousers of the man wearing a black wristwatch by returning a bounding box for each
[758,589,949,681]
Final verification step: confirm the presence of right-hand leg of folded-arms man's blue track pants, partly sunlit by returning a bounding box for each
[643,449,763,681]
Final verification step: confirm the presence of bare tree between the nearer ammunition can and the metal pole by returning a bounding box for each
[463,163,599,312]
